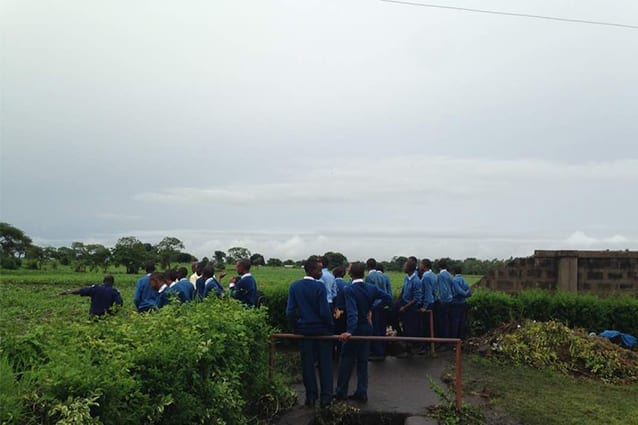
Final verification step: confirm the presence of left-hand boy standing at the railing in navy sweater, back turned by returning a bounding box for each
[286,257,333,407]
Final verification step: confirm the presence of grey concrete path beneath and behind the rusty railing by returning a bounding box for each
[276,352,455,425]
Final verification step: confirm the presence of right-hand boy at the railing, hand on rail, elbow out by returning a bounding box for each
[335,262,392,403]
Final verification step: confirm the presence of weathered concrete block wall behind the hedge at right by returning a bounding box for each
[477,251,638,296]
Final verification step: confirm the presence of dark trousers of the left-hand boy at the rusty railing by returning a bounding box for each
[299,334,334,404]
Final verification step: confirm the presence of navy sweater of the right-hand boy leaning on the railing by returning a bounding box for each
[344,279,392,335]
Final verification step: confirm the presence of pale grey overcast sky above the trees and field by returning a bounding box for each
[0,0,638,259]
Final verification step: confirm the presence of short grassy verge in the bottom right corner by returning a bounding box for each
[463,355,638,425]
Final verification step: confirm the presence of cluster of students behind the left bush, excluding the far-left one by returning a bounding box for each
[133,259,257,313]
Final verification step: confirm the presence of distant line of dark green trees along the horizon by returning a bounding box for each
[0,223,511,275]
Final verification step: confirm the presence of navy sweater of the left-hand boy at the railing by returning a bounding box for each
[286,276,332,335]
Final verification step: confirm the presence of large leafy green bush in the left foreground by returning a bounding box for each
[0,298,291,424]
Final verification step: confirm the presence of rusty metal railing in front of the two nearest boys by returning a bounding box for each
[269,333,463,410]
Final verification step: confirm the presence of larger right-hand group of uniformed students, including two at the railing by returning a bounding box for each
[286,256,472,407]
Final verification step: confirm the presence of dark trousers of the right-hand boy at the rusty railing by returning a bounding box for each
[335,323,372,398]
